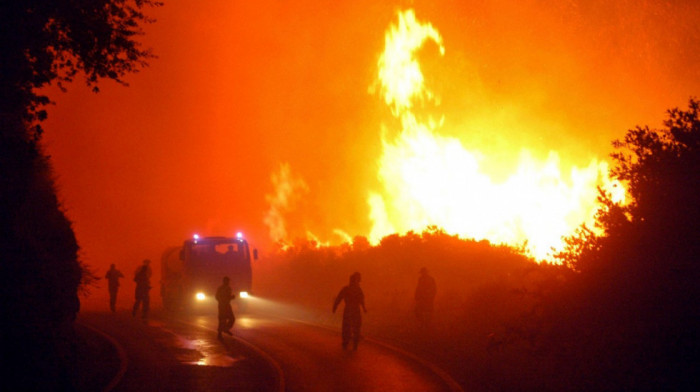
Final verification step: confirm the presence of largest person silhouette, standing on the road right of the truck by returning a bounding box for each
[333,272,367,350]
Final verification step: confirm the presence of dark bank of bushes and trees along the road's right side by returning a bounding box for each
[256,100,700,391]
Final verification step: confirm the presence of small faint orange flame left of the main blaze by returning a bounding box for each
[264,162,309,246]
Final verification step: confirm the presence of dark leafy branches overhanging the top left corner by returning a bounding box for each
[0,0,160,136]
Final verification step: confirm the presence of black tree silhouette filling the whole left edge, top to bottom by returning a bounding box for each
[0,0,158,390]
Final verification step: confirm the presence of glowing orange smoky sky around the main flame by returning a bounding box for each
[39,0,700,288]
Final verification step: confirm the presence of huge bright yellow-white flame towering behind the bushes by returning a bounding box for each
[368,10,625,259]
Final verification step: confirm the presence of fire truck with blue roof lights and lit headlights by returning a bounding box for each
[160,233,258,310]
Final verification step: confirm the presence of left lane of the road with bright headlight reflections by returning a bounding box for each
[78,311,279,391]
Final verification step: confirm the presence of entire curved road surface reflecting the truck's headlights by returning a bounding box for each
[80,306,460,392]
